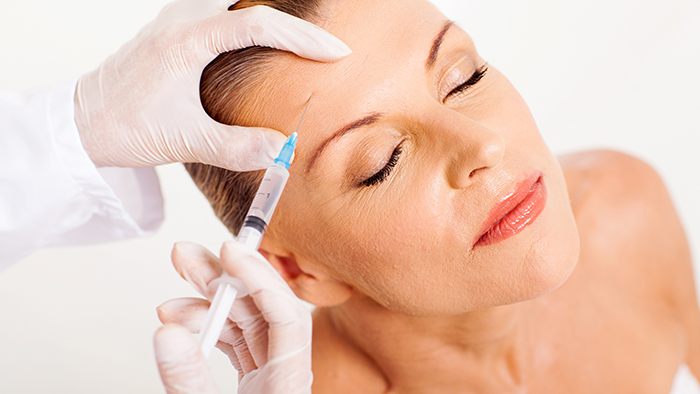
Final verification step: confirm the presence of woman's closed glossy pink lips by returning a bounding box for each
[474,171,547,247]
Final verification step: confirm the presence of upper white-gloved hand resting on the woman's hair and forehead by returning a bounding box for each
[75,0,350,171]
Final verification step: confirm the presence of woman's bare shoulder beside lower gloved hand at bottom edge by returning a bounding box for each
[312,309,388,394]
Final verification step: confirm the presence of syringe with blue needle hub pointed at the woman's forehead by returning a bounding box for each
[199,98,311,357]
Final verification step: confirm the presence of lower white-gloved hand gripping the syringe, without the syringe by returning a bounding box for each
[155,242,313,394]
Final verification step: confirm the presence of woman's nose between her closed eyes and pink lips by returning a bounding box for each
[434,112,505,189]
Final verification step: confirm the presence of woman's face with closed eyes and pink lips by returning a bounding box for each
[247,0,578,316]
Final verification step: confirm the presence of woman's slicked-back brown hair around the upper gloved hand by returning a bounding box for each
[185,0,320,234]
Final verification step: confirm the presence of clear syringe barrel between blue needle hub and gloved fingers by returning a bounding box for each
[241,164,289,233]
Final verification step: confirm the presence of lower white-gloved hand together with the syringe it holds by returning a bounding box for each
[155,97,313,394]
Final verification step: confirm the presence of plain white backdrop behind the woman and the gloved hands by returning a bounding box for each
[0,0,700,393]
